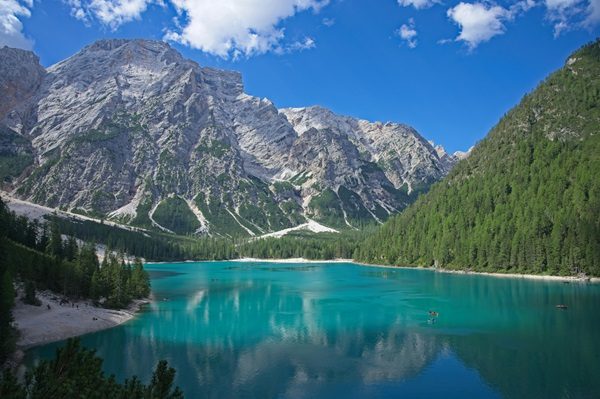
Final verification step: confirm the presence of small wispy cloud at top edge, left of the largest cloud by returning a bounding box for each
[64,0,152,29]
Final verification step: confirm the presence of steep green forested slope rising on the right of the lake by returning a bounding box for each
[356,41,600,276]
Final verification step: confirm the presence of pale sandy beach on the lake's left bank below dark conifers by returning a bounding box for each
[13,291,147,349]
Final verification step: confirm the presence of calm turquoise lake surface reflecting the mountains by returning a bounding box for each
[27,262,600,398]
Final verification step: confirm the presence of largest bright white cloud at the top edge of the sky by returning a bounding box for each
[165,0,329,58]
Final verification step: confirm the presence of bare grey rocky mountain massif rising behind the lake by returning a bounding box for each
[0,40,457,236]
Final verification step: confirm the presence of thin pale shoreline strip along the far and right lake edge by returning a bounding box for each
[147,257,600,284]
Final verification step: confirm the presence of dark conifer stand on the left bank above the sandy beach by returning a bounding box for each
[0,200,150,364]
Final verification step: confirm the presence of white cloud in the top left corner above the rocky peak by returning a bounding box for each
[0,0,33,50]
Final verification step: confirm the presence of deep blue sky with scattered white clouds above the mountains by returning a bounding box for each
[0,0,600,151]
